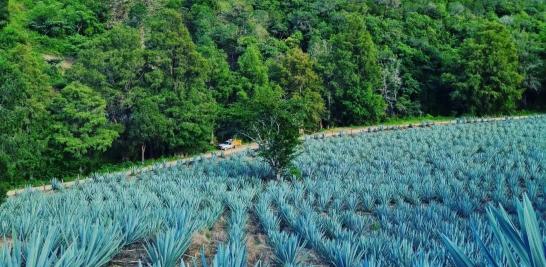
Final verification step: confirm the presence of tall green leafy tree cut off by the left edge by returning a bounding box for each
[0,45,54,179]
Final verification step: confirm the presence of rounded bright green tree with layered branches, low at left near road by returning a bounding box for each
[48,83,118,172]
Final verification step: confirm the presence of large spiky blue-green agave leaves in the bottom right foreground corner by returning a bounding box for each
[442,194,546,267]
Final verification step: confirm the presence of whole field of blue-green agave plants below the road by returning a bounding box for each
[0,116,546,267]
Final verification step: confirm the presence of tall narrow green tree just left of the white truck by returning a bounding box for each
[146,9,217,153]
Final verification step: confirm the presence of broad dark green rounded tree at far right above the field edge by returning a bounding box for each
[444,23,523,115]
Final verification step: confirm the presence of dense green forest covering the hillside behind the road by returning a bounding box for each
[0,0,546,182]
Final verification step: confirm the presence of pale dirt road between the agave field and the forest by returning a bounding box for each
[7,115,533,197]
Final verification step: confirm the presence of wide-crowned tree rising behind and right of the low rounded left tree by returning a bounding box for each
[66,26,146,125]
